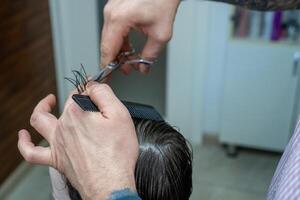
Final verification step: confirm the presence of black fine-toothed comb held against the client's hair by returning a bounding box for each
[72,94,164,122]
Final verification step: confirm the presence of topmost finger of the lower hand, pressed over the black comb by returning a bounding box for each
[87,82,124,118]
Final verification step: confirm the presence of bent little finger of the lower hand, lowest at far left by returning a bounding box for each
[18,130,52,166]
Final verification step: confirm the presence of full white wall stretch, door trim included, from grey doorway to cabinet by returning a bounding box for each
[167,0,232,138]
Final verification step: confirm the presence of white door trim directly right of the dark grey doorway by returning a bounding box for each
[166,0,208,143]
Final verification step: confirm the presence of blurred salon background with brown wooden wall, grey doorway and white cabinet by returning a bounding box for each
[0,0,300,200]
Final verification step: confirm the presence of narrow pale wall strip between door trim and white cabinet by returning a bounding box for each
[203,2,232,134]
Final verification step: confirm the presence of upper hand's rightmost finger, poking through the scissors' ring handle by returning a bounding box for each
[139,37,167,74]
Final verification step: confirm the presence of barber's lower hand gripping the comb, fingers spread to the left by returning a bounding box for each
[18,82,138,199]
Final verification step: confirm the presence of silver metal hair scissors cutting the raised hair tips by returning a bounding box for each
[91,49,155,82]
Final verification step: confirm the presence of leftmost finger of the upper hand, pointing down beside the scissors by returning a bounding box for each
[101,22,129,67]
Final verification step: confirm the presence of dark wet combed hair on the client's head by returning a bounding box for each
[67,119,192,200]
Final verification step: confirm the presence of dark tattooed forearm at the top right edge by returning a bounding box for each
[206,0,300,11]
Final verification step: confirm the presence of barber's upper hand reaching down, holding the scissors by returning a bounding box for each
[101,0,180,73]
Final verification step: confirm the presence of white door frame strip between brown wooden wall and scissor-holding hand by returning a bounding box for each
[49,0,100,109]
